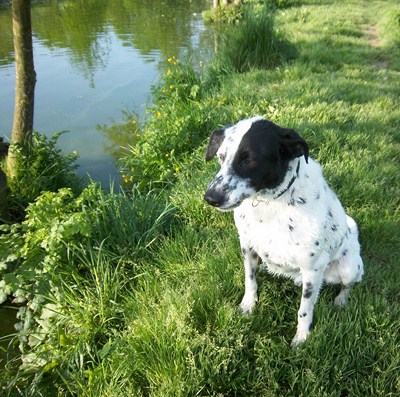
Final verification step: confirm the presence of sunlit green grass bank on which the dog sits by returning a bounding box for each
[0,0,400,397]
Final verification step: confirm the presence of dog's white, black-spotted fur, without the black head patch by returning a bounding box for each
[205,118,363,346]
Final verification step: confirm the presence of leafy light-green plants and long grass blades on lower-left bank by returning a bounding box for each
[0,184,173,388]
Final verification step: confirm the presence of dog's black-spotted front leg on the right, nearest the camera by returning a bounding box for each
[291,270,323,347]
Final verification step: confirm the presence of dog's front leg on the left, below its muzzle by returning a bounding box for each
[240,245,259,313]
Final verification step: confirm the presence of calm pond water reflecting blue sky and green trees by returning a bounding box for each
[0,0,213,187]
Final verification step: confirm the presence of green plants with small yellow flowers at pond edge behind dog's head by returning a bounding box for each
[117,56,233,190]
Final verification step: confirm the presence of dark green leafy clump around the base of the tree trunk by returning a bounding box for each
[1,132,81,219]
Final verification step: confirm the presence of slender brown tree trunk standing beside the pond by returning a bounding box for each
[7,0,36,177]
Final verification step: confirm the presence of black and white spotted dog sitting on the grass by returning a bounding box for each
[204,117,363,346]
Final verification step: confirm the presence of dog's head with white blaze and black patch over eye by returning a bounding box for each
[204,117,308,211]
